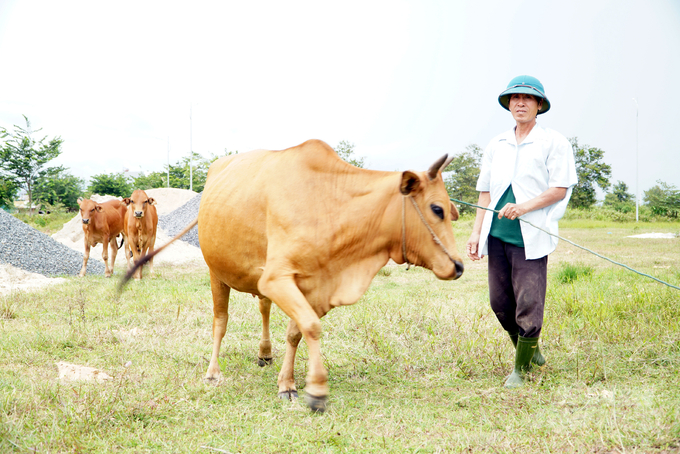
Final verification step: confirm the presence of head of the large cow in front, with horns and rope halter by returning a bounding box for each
[400,155,464,279]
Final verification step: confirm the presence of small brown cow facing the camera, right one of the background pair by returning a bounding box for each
[123,189,158,279]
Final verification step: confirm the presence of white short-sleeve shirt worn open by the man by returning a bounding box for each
[477,124,578,260]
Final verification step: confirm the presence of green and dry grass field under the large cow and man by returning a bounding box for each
[0,219,680,453]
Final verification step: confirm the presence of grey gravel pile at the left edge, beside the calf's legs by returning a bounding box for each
[0,210,104,276]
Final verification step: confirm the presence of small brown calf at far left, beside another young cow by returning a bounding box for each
[78,197,126,277]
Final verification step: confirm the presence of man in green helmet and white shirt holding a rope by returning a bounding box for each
[467,76,577,388]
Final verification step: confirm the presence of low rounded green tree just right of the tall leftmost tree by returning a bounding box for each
[33,166,85,208]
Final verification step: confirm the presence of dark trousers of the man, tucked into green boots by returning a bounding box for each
[488,236,548,337]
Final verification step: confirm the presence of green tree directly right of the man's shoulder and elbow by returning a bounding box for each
[569,137,612,208]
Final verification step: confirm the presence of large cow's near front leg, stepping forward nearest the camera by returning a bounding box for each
[258,272,328,412]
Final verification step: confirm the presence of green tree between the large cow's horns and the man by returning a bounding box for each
[444,144,484,214]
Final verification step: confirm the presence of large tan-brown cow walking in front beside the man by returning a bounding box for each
[123,140,463,411]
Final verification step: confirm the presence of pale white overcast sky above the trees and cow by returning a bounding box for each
[0,0,680,199]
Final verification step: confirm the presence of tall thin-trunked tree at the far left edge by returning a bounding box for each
[0,115,62,213]
